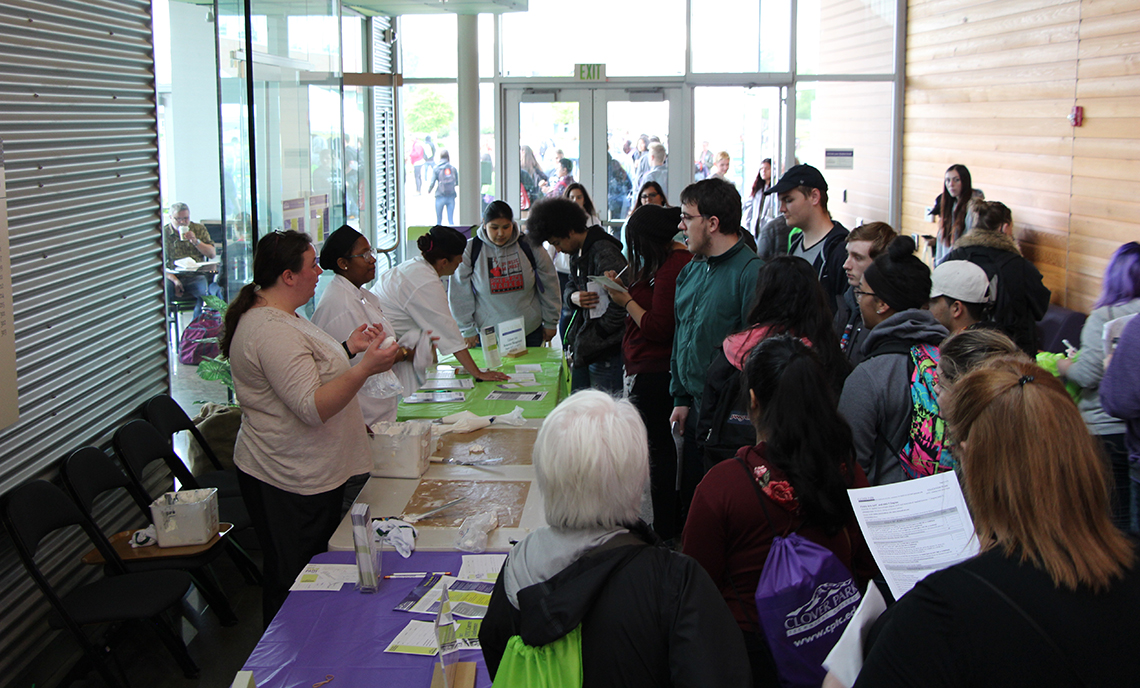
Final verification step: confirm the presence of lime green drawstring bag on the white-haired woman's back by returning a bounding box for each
[492,625,583,688]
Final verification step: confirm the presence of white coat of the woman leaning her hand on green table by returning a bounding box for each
[372,255,467,354]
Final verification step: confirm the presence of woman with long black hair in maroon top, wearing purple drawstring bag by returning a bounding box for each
[683,335,878,686]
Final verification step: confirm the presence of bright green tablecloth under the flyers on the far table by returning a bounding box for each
[398,347,569,420]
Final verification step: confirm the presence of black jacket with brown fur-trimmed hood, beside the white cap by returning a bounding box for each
[946,230,1052,357]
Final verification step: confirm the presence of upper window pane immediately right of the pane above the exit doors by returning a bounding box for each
[692,0,791,74]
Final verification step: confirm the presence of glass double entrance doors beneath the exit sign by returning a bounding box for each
[504,87,692,227]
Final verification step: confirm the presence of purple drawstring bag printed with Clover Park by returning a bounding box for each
[756,533,863,688]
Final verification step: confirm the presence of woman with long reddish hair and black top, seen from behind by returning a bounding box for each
[855,357,1140,688]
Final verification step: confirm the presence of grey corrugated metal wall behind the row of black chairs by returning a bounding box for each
[0,0,168,677]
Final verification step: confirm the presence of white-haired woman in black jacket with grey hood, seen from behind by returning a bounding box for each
[479,390,751,687]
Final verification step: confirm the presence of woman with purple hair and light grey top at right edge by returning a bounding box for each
[1057,241,1140,530]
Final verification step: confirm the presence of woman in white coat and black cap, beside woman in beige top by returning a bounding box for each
[312,224,415,426]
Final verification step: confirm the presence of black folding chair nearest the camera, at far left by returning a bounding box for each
[0,481,198,686]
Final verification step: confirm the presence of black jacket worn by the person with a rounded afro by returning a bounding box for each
[562,224,626,368]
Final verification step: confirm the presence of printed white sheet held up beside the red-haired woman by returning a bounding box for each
[847,473,978,599]
